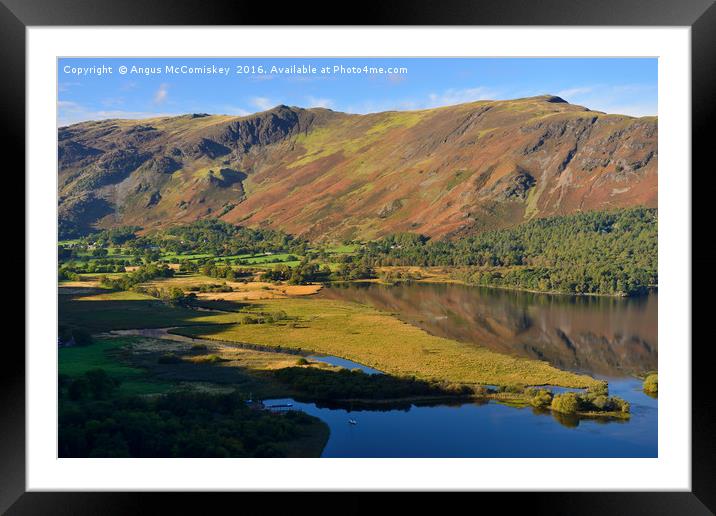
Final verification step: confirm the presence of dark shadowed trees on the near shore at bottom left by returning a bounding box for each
[58,369,324,457]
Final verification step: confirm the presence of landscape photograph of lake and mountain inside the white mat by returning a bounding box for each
[53,57,659,458]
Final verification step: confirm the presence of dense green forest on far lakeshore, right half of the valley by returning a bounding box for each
[362,208,657,295]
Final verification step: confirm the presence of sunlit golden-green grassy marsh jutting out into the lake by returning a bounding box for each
[178,298,597,387]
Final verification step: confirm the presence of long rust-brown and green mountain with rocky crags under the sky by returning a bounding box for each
[58,95,658,241]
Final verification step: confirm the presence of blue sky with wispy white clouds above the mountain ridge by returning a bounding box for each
[57,58,658,126]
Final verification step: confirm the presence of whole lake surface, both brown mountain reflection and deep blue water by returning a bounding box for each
[288,284,658,457]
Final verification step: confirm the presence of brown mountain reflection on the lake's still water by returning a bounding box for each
[321,284,658,377]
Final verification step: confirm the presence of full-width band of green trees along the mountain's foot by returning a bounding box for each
[60,208,658,295]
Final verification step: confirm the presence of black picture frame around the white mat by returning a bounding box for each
[7,0,716,515]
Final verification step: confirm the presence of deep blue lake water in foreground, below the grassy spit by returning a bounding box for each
[270,378,658,457]
